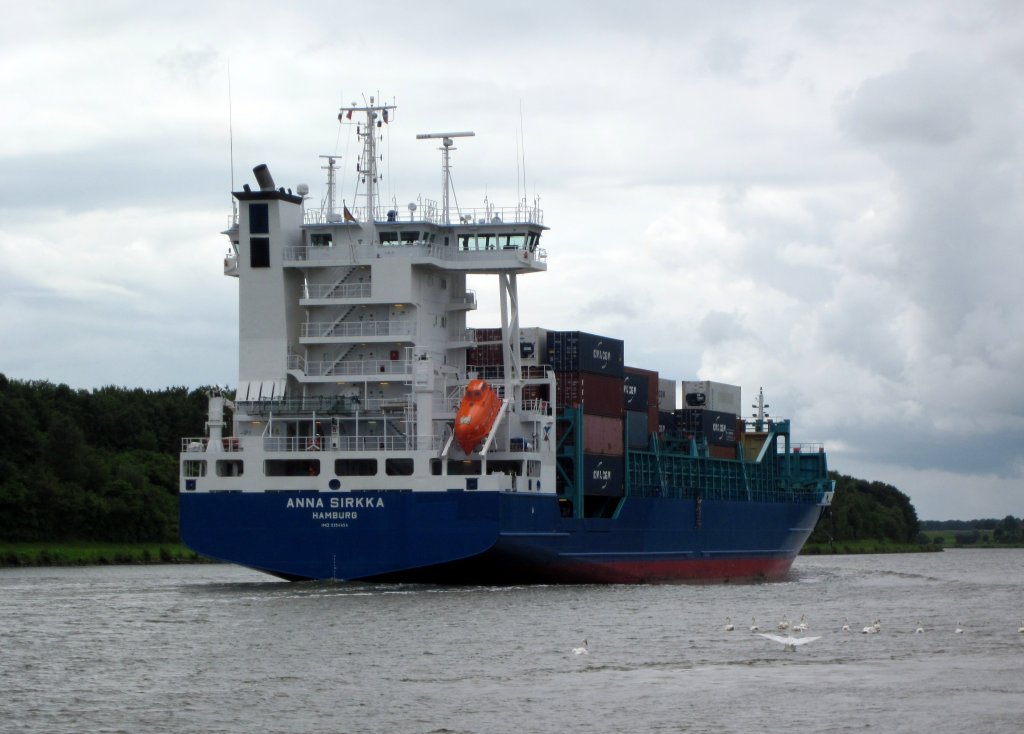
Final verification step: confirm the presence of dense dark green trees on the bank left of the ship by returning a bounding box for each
[0,374,208,543]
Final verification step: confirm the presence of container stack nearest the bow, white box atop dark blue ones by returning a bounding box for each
[676,380,741,459]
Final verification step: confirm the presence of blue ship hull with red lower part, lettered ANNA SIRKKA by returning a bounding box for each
[180,491,822,584]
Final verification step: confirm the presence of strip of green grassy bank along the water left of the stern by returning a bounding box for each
[0,541,208,567]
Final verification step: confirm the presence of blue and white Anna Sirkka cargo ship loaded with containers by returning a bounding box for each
[180,97,834,585]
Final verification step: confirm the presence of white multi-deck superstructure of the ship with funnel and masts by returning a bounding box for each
[182,97,555,493]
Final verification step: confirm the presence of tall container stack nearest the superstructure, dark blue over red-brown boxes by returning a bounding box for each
[547,332,626,496]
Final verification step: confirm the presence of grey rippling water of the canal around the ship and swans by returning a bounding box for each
[0,550,1024,734]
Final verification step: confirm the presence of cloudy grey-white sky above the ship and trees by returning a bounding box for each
[0,0,1024,520]
